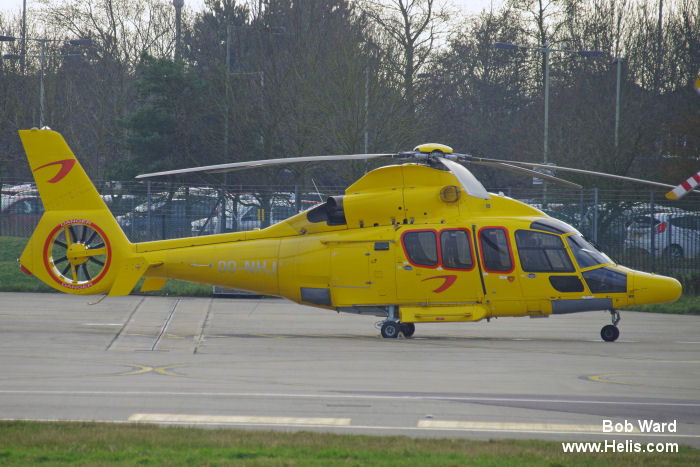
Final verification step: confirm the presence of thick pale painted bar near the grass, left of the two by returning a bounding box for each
[129,413,351,426]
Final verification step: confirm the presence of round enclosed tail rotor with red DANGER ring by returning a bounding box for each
[44,220,112,289]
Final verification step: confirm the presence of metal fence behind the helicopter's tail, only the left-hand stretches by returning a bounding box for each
[0,181,344,242]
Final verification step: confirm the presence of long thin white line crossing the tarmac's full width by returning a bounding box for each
[0,389,700,407]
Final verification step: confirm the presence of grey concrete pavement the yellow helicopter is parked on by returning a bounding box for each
[0,293,700,447]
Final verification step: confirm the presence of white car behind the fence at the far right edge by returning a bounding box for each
[625,212,700,259]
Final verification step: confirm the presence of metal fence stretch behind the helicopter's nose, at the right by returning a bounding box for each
[510,188,700,275]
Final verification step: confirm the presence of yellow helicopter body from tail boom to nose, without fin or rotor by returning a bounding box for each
[135,164,680,323]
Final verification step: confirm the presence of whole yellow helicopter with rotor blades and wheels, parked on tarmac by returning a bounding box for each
[19,129,681,341]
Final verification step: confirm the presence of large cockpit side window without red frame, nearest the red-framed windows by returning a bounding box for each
[515,230,574,272]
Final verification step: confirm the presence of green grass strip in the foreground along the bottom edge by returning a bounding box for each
[0,421,700,467]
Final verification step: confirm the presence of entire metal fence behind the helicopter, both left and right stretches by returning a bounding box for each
[0,182,700,275]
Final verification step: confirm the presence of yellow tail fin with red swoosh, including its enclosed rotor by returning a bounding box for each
[19,129,148,295]
